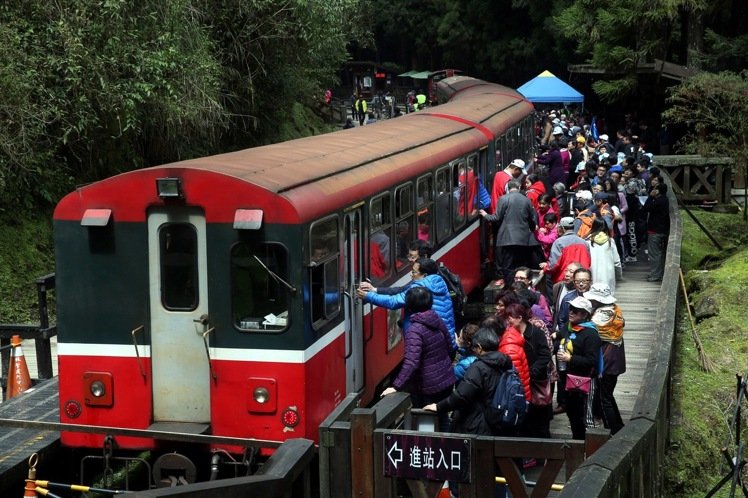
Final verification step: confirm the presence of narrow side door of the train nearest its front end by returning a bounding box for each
[343,208,364,393]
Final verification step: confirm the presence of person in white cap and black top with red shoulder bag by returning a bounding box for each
[556,296,601,441]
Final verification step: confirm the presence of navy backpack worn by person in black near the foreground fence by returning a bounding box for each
[484,366,527,433]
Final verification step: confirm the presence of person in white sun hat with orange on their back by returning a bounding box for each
[584,282,626,434]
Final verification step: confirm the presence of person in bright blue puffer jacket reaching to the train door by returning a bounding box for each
[357,258,457,353]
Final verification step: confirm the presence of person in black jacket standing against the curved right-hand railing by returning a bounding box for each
[641,183,670,282]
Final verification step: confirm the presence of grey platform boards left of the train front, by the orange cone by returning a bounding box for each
[0,377,60,496]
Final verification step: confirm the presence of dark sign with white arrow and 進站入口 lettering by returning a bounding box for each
[382,432,470,482]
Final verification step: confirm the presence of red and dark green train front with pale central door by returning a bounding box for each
[54,167,346,451]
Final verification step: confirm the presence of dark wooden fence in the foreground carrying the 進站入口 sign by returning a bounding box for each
[319,393,609,498]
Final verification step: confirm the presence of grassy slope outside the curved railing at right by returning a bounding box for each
[663,211,748,498]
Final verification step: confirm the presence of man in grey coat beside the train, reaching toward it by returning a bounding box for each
[480,180,540,287]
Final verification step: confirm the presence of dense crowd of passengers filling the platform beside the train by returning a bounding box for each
[358,112,669,498]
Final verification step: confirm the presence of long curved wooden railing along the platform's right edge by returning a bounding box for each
[559,174,683,498]
